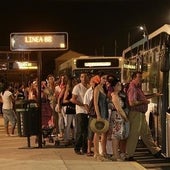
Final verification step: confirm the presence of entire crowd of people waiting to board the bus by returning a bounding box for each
[0,72,164,161]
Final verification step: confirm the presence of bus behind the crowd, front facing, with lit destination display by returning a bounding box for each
[58,56,123,80]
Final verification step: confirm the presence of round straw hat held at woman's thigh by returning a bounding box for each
[90,119,109,134]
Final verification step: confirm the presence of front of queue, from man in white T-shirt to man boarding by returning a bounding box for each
[67,72,162,161]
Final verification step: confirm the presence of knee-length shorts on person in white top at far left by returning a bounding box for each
[2,109,17,127]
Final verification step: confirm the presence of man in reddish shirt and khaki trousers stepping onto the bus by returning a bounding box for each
[126,72,161,161]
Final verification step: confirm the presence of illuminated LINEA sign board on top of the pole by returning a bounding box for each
[10,32,68,51]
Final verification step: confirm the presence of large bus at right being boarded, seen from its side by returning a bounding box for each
[122,24,170,157]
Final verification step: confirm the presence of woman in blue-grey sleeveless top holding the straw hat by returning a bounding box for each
[94,74,108,161]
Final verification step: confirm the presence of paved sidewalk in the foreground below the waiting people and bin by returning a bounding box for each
[0,116,145,170]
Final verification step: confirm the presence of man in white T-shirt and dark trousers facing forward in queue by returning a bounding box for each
[71,73,89,155]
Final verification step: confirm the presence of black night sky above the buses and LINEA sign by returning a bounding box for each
[0,0,170,55]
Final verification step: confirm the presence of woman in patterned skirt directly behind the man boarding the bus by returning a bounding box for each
[108,78,128,160]
